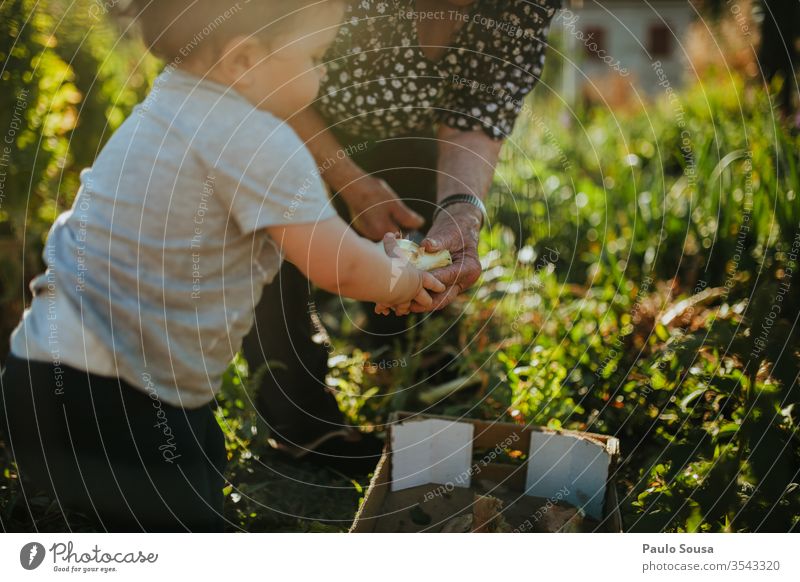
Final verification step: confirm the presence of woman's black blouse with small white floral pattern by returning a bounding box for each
[316,0,561,140]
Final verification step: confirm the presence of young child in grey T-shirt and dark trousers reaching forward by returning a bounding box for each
[2,0,444,531]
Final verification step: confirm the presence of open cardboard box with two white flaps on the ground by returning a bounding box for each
[350,412,622,533]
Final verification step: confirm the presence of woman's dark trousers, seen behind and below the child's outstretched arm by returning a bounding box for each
[243,136,437,444]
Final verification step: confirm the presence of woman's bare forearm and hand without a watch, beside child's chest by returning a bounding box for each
[290,107,425,241]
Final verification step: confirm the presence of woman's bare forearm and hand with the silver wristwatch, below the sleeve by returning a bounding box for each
[412,125,503,312]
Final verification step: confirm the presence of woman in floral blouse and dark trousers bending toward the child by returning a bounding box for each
[245,0,561,469]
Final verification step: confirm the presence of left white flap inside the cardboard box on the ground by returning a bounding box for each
[391,418,475,491]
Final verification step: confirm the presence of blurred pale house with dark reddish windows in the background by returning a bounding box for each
[552,0,696,106]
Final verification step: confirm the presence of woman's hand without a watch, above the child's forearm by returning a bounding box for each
[340,176,425,241]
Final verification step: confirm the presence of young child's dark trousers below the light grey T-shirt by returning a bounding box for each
[0,355,226,532]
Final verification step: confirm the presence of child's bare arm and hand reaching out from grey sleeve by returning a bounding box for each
[267,216,444,306]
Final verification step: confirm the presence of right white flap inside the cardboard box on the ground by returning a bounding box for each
[525,432,611,520]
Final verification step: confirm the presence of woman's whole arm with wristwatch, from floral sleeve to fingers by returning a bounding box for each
[416,0,561,311]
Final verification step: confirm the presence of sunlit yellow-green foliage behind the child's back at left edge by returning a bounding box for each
[0,0,157,357]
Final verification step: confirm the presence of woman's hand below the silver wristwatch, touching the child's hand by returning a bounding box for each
[411,204,482,313]
